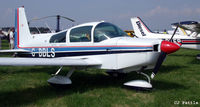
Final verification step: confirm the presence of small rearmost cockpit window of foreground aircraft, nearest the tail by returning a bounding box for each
[49,31,67,43]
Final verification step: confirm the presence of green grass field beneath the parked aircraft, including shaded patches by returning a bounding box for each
[0,39,200,107]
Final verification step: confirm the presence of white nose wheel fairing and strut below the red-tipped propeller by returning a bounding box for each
[124,67,152,90]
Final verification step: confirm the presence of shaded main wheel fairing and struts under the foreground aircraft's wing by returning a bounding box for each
[47,66,75,86]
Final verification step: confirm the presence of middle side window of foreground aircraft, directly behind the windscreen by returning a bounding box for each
[70,26,92,42]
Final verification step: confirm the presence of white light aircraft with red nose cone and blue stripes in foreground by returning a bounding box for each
[0,7,180,89]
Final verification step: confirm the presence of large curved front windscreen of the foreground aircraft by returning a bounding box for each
[94,23,128,42]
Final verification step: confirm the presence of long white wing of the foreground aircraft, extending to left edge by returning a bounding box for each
[0,57,101,66]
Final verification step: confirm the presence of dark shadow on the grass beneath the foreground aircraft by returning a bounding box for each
[0,71,186,107]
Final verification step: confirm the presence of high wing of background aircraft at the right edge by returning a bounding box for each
[172,21,200,33]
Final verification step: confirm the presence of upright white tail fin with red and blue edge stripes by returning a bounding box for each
[14,7,31,49]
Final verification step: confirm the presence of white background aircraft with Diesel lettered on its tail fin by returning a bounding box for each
[131,17,200,50]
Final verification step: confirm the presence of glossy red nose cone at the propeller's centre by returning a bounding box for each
[161,41,181,54]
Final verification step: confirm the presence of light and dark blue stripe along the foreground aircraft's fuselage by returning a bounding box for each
[18,47,153,57]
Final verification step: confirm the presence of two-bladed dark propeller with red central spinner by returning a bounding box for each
[151,26,180,79]
